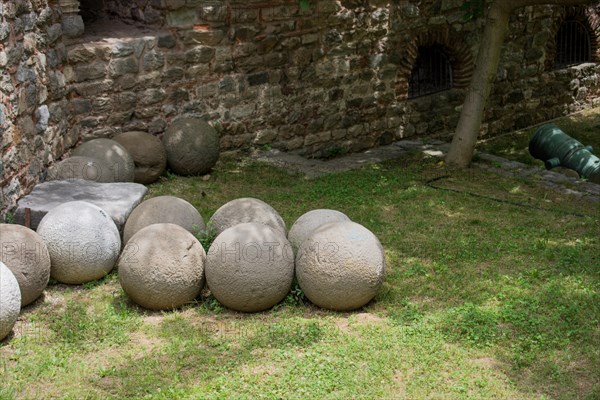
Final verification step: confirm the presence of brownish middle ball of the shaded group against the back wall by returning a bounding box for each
[113,131,167,185]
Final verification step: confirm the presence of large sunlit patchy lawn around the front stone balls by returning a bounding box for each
[0,120,600,400]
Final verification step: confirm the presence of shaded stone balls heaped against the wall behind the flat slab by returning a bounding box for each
[48,117,219,185]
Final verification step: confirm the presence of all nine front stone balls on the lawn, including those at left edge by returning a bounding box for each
[0,196,385,340]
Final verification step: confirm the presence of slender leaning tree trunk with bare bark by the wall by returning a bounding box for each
[446,0,593,168]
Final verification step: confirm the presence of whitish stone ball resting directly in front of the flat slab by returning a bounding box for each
[37,201,121,284]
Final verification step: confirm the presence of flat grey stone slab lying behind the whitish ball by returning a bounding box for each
[15,179,148,232]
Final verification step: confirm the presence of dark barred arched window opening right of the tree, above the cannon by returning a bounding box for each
[554,20,592,69]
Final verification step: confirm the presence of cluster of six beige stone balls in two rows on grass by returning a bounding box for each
[118,196,385,312]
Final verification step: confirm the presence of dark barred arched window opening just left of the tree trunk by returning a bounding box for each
[408,45,452,98]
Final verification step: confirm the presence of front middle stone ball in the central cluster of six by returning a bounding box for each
[206,222,294,312]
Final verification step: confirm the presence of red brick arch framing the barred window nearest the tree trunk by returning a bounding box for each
[396,29,475,100]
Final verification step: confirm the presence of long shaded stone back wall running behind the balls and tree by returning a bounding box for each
[0,0,600,219]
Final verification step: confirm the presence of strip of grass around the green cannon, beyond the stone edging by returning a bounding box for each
[477,107,600,166]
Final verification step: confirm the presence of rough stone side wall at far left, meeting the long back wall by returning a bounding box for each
[0,0,68,217]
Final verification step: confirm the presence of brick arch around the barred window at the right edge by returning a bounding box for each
[545,6,600,71]
